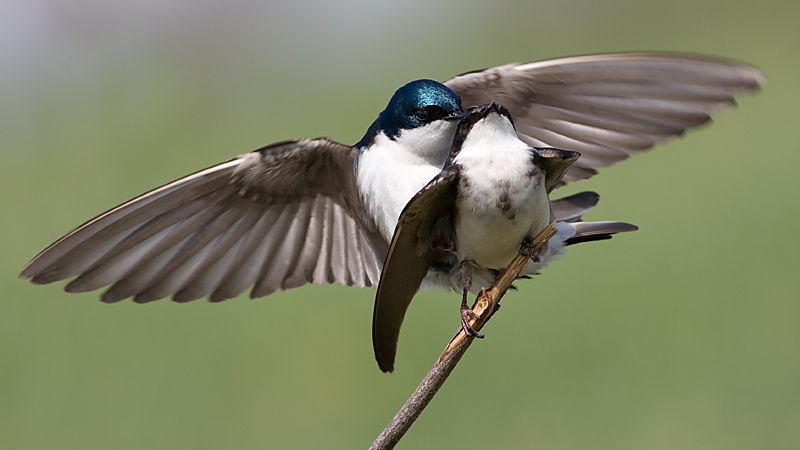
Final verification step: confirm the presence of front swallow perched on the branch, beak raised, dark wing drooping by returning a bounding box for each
[373,103,637,372]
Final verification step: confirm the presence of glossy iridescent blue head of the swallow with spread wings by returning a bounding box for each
[356,80,464,147]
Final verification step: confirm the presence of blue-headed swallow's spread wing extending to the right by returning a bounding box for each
[444,53,764,184]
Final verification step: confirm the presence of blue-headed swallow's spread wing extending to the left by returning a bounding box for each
[21,138,388,302]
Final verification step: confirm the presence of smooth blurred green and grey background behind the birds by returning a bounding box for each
[0,0,800,450]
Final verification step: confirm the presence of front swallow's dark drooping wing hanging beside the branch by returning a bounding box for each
[372,166,458,372]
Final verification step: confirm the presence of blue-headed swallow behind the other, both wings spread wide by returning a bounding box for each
[21,54,762,312]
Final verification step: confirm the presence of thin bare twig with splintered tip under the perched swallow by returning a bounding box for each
[370,221,557,450]
